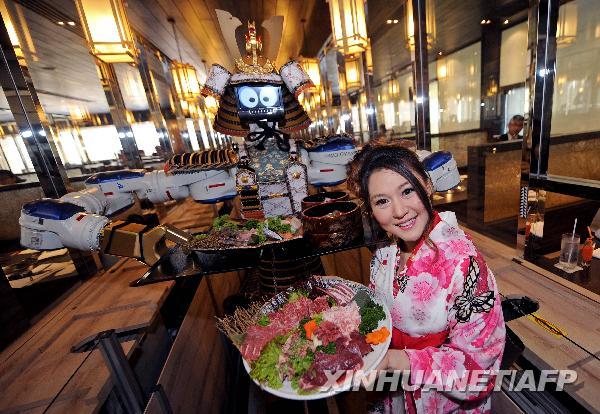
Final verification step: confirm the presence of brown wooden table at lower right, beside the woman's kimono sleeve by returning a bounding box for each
[467,230,600,412]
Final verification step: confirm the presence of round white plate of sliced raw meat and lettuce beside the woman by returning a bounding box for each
[238,276,392,400]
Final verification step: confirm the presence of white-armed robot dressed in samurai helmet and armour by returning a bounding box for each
[19,23,460,265]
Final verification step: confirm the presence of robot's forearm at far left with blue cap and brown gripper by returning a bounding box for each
[19,199,191,265]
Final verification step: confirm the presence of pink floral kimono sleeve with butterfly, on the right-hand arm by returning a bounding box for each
[406,254,505,401]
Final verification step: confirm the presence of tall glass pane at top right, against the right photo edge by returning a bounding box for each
[548,0,600,180]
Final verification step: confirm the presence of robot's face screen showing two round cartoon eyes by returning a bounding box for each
[235,83,284,122]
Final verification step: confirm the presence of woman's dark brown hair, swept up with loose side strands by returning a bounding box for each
[349,144,434,244]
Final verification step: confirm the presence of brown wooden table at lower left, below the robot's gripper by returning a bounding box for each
[0,200,220,414]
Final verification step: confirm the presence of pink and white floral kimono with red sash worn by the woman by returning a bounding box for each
[371,212,505,414]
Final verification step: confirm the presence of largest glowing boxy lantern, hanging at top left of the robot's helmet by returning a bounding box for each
[75,0,137,63]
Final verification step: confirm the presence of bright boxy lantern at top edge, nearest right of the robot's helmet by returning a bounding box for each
[329,0,367,55]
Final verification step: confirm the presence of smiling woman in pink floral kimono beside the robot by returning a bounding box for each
[350,145,505,413]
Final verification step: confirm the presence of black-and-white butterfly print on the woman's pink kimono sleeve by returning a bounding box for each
[452,256,496,322]
